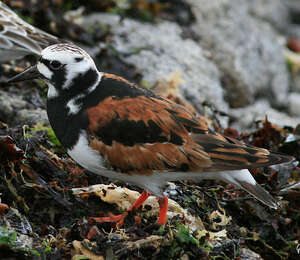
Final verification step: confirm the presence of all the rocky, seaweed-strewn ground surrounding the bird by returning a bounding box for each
[0,0,300,259]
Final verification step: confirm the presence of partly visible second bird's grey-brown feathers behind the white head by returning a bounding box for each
[0,1,61,62]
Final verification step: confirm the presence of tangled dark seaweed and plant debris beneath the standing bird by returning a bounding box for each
[0,116,300,259]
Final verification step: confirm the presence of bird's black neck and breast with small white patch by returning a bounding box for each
[47,70,102,148]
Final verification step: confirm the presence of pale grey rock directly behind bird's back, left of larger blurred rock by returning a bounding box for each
[84,13,228,111]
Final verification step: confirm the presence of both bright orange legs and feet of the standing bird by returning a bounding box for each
[89,190,168,227]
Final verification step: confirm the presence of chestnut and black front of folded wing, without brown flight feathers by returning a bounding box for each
[87,96,211,174]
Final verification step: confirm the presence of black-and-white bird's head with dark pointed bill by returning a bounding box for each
[8,43,99,98]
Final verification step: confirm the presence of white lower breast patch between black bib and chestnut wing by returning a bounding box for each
[67,131,103,171]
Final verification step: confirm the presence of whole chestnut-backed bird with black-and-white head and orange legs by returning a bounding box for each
[8,43,293,225]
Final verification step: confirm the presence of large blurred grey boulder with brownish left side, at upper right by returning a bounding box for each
[188,0,289,107]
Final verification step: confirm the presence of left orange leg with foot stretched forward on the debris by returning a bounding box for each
[89,190,151,226]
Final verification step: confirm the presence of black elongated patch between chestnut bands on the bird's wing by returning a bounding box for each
[98,118,168,146]
